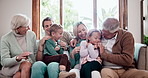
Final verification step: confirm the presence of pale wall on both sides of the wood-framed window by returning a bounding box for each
[0,0,141,42]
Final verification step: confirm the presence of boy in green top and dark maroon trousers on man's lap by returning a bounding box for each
[43,24,76,78]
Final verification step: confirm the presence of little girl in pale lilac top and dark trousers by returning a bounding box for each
[80,29,102,78]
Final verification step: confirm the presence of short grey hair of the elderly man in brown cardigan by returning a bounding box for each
[103,18,120,33]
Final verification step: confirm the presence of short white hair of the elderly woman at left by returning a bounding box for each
[11,14,30,30]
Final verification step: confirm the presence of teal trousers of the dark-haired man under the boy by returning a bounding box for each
[31,61,59,78]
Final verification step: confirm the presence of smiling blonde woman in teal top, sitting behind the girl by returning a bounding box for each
[70,22,87,78]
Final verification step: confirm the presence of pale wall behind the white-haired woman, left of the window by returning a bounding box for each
[0,0,32,38]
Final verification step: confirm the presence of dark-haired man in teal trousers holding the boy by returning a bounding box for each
[31,17,71,78]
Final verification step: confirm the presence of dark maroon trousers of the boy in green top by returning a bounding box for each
[43,54,70,71]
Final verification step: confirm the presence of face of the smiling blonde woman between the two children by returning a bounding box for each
[77,24,87,39]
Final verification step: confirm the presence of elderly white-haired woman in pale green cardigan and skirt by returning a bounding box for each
[1,14,37,78]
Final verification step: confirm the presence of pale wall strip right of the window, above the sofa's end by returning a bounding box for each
[127,0,141,43]
